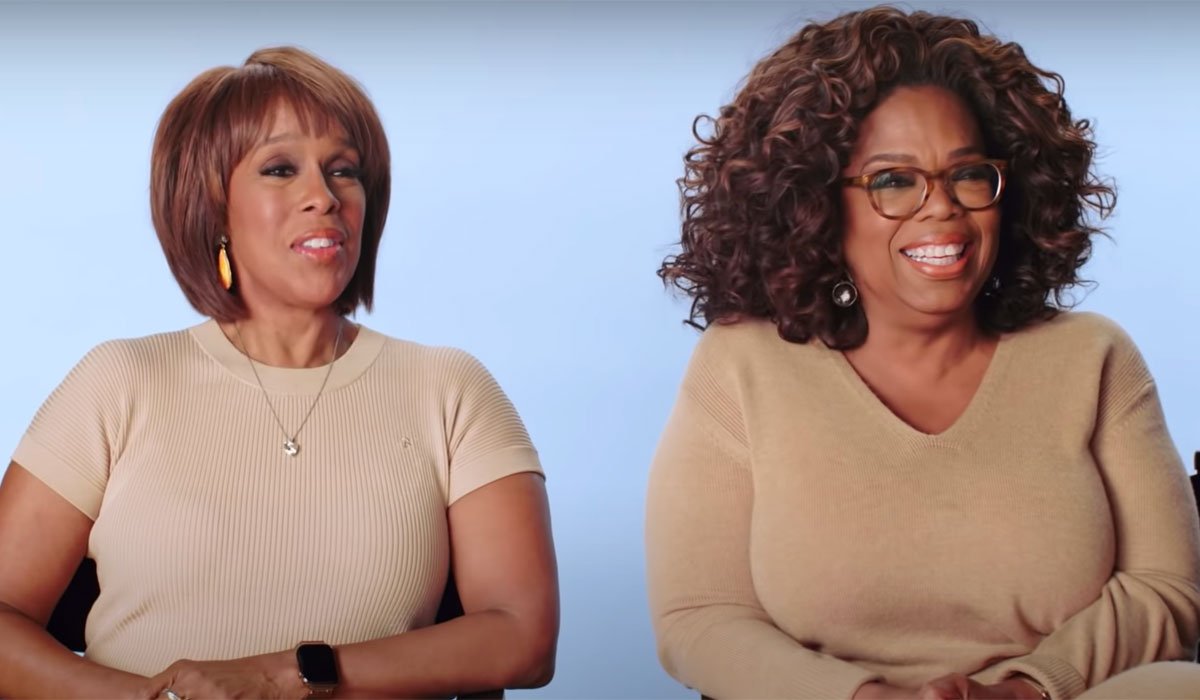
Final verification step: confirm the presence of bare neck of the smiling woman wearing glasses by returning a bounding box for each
[846,315,995,377]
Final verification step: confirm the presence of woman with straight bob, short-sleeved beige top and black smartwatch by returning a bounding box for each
[0,48,558,700]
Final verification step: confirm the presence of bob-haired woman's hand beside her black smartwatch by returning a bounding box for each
[146,652,308,700]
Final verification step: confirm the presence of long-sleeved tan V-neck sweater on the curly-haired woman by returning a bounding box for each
[647,313,1200,700]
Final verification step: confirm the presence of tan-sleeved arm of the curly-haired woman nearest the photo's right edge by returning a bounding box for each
[980,371,1200,700]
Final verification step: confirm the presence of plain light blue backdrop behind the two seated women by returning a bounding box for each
[0,2,1200,698]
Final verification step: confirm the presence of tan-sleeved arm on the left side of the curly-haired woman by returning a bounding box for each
[646,381,880,699]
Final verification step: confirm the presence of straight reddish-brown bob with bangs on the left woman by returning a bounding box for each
[150,47,391,322]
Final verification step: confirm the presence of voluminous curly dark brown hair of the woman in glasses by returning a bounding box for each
[659,7,1116,348]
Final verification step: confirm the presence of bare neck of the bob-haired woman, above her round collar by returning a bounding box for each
[221,309,355,367]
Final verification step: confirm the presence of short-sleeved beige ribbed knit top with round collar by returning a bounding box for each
[13,321,541,675]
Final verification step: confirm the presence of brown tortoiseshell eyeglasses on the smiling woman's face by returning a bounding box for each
[842,160,1008,220]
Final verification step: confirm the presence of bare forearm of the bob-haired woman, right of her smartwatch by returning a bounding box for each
[328,610,556,698]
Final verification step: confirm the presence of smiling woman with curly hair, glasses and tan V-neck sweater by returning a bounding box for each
[647,8,1200,700]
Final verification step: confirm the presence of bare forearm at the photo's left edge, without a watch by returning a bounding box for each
[0,604,146,699]
